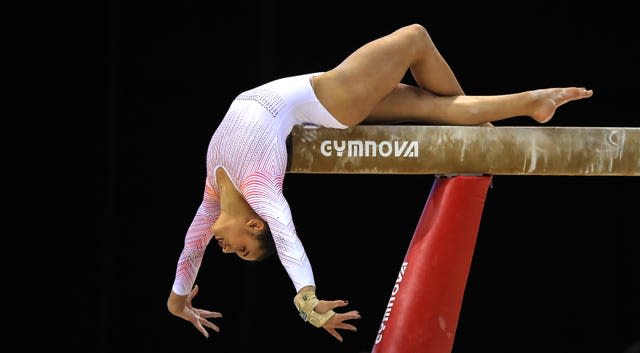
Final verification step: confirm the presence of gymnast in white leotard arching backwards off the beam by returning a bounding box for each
[167,24,593,341]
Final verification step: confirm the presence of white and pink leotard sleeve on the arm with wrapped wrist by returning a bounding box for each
[241,172,315,292]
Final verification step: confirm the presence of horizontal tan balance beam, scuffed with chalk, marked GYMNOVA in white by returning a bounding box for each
[287,125,640,176]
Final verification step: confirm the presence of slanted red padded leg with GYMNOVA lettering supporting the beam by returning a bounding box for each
[372,176,491,353]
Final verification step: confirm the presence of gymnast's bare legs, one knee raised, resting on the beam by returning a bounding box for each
[312,24,593,126]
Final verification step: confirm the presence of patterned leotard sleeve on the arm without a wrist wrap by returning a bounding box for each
[172,184,220,295]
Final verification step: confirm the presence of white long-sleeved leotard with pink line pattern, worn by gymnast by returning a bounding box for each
[173,73,347,295]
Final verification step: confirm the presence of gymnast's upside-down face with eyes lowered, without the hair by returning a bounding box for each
[213,222,263,261]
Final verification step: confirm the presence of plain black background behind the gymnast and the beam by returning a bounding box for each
[7,1,640,353]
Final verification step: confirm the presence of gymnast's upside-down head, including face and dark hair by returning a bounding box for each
[211,214,276,261]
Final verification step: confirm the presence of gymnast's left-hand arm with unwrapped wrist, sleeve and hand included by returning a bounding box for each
[167,187,222,337]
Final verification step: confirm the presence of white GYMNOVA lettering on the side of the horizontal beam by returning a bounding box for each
[320,140,418,158]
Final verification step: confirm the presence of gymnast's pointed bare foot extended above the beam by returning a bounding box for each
[531,87,593,123]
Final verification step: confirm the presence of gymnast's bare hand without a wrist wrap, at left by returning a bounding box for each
[167,285,222,338]
